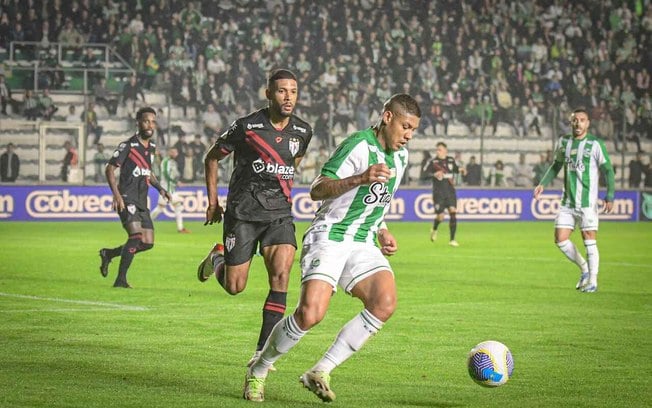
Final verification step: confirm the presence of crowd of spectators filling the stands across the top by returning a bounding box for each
[0,0,652,180]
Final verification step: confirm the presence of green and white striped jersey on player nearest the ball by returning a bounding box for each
[306,128,408,245]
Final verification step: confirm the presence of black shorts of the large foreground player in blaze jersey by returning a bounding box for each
[222,212,297,265]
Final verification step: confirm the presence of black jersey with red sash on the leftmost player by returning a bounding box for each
[109,135,156,210]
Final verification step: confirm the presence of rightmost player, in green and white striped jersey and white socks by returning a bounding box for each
[534,109,614,293]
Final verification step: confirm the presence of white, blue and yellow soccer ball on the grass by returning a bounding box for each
[466,340,514,387]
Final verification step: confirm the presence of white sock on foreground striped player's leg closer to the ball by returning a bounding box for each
[312,309,383,373]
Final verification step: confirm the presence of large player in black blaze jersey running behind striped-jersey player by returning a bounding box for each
[197,69,312,363]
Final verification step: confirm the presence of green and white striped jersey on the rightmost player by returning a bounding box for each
[553,133,614,208]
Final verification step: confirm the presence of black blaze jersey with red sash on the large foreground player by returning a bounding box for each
[215,108,312,221]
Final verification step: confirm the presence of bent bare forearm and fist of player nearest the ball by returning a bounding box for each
[310,163,391,201]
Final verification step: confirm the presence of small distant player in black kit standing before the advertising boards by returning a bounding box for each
[426,142,459,247]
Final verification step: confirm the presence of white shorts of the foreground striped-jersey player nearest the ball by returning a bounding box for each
[301,240,394,294]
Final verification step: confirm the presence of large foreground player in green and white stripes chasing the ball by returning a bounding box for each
[245,94,421,401]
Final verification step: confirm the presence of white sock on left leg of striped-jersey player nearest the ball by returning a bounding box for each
[250,314,308,378]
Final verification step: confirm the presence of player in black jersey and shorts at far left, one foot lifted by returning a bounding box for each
[100,108,172,288]
